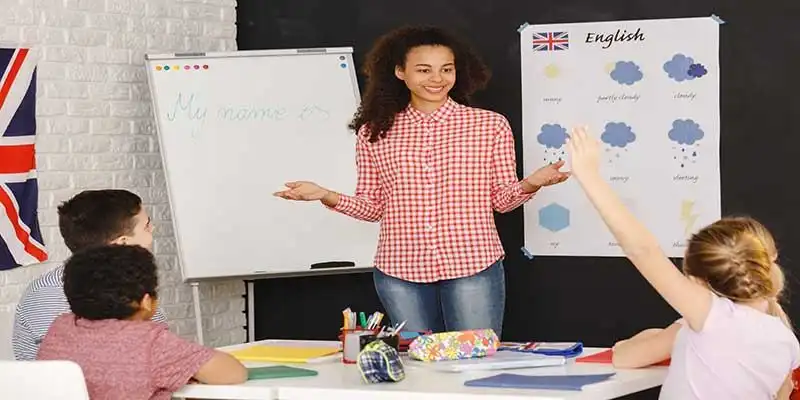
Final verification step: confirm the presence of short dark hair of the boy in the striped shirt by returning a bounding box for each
[58,189,142,252]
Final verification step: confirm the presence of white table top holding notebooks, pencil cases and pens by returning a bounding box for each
[175,344,667,400]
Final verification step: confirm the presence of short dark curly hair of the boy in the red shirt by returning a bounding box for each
[64,245,158,320]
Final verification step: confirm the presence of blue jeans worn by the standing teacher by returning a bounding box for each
[373,260,506,337]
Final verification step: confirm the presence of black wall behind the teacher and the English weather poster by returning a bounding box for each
[237,0,800,346]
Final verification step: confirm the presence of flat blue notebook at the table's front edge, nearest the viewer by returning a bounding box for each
[464,373,614,391]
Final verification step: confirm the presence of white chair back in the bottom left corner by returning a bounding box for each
[0,361,89,400]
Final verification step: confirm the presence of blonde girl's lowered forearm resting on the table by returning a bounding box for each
[611,323,681,368]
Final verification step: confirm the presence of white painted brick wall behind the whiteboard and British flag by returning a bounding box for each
[0,0,245,346]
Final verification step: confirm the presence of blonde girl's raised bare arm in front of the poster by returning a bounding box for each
[567,129,712,331]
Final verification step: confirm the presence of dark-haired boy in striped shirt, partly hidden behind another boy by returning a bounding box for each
[12,189,166,361]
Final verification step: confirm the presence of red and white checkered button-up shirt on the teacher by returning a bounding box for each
[333,99,533,282]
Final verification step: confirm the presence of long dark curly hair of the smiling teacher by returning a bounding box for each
[349,26,491,142]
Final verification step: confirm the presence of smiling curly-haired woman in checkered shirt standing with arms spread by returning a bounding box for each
[275,27,569,336]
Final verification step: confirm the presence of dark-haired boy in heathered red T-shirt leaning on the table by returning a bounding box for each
[37,245,247,400]
